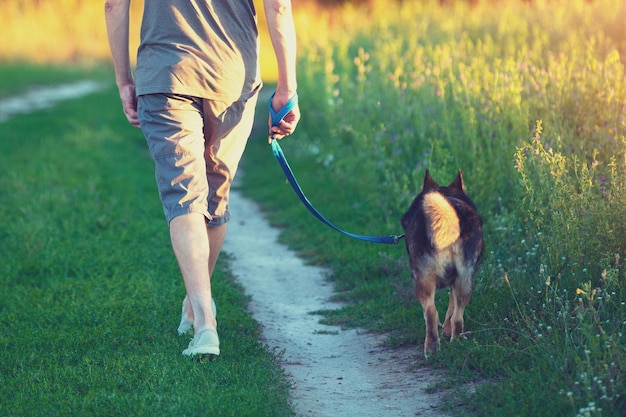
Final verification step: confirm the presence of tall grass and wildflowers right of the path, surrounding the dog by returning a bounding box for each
[238,0,626,417]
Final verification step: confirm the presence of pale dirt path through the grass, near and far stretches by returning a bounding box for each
[0,82,445,417]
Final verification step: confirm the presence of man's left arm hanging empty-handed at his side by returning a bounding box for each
[104,0,139,127]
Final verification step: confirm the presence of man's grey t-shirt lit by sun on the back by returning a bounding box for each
[135,0,261,101]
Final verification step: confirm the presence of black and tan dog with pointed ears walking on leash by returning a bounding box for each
[401,170,483,357]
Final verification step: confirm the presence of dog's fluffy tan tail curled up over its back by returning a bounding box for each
[423,192,461,250]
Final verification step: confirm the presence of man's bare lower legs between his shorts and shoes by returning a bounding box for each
[170,213,226,333]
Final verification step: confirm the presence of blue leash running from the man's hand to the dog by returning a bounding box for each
[267,94,404,245]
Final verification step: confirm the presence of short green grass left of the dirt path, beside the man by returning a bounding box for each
[0,73,291,416]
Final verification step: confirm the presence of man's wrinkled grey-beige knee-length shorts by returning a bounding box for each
[138,94,257,227]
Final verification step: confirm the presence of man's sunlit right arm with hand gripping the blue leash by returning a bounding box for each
[263,0,300,139]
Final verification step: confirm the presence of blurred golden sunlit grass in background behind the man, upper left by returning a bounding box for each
[0,0,276,82]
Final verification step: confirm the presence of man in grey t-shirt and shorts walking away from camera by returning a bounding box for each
[105,0,300,356]
